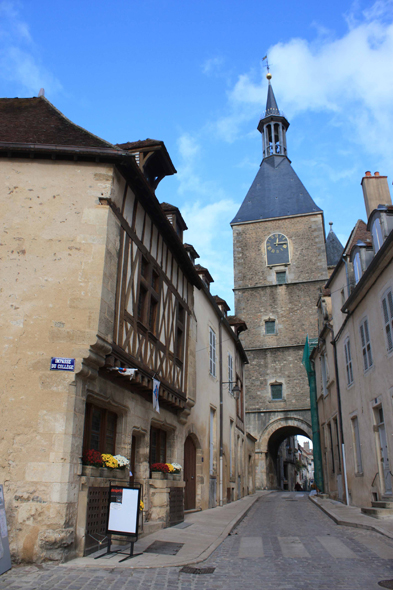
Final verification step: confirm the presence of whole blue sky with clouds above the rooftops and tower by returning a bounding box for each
[0,0,393,313]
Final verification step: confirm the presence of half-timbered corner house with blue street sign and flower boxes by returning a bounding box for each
[0,97,201,561]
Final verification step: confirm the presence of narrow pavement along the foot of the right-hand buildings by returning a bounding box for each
[309,496,393,539]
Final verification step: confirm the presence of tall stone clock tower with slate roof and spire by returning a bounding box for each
[231,73,328,488]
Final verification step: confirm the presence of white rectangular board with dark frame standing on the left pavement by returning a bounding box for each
[106,485,141,536]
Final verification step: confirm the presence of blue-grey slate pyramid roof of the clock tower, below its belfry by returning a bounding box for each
[231,156,322,224]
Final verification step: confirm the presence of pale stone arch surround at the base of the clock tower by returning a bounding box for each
[256,416,312,489]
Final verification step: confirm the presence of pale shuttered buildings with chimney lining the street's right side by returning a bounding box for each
[312,172,393,507]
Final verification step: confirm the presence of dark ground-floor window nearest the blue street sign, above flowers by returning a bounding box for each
[83,403,117,455]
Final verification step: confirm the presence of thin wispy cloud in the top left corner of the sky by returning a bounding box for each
[0,1,61,96]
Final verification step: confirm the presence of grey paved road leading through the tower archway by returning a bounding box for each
[0,492,393,590]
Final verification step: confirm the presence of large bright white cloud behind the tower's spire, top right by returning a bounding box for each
[212,0,393,169]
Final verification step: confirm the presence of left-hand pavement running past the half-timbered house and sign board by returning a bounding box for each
[59,491,270,569]
